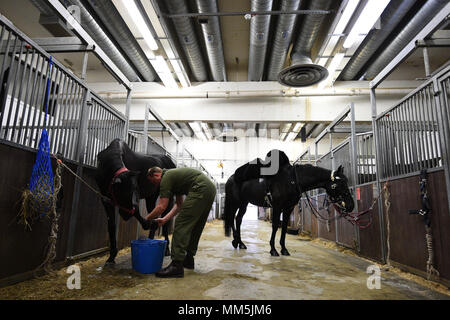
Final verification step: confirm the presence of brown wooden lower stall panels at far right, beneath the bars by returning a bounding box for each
[384,170,450,285]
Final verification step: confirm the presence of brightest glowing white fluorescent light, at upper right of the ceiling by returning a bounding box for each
[343,0,390,49]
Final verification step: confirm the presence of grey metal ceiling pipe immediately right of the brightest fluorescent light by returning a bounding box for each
[339,0,417,80]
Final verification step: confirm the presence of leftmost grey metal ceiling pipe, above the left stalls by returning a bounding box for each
[63,0,141,82]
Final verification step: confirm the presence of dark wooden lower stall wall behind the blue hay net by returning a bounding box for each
[0,143,136,286]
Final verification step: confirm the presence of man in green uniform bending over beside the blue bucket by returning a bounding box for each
[146,167,216,277]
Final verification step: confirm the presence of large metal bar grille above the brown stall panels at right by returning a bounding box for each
[372,81,442,179]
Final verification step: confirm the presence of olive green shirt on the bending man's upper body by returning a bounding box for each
[159,168,203,198]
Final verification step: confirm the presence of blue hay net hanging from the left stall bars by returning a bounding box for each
[28,56,54,216]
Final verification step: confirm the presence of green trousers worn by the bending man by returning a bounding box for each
[171,175,216,261]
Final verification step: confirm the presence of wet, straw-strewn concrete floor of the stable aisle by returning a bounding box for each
[0,221,450,300]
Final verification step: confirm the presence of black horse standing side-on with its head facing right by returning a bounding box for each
[225,164,354,256]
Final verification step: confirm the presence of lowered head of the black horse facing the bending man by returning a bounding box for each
[111,171,139,219]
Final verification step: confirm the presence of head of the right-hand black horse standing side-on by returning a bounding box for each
[324,166,355,212]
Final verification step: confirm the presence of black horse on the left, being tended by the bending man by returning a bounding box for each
[96,139,175,265]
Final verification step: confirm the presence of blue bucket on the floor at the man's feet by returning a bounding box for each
[131,239,167,273]
